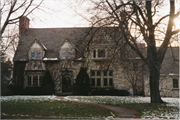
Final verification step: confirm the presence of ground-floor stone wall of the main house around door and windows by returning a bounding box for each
[22,60,146,94]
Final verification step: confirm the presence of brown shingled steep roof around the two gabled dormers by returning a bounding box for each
[13,27,117,61]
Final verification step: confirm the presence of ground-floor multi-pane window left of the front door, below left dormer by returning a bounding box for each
[27,75,43,87]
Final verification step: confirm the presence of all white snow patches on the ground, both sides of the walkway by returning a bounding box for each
[0,95,180,119]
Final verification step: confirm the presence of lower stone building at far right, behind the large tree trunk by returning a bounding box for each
[144,47,179,97]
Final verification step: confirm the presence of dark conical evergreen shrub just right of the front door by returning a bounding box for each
[73,67,90,95]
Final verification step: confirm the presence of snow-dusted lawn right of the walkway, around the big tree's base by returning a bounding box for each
[66,96,180,119]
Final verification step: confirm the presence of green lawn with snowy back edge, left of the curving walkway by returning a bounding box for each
[1,96,113,119]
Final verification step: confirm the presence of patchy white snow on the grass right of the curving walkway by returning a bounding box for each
[66,96,180,119]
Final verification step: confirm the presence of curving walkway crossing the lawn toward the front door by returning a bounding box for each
[57,96,137,118]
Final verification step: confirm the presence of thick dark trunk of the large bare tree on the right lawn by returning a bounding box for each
[149,63,164,103]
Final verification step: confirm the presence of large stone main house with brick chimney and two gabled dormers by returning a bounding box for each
[13,17,179,95]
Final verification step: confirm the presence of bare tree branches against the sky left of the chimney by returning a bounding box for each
[0,0,43,59]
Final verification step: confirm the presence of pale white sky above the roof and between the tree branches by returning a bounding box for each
[2,0,180,60]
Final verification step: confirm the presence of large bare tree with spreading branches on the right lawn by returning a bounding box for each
[77,0,179,103]
